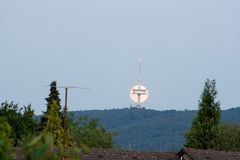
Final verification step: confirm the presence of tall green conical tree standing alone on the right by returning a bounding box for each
[185,79,220,149]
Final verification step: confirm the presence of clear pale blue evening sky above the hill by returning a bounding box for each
[0,0,240,114]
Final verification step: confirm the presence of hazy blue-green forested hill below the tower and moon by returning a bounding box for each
[69,108,240,151]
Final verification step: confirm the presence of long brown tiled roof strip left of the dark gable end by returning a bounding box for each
[81,149,178,160]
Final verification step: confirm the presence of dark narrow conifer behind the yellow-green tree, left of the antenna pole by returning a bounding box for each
[40,81,63,130]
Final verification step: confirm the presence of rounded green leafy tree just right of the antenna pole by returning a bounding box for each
[68,117,115,148]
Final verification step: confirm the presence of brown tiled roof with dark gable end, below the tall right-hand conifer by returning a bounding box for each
[178,148,240,160]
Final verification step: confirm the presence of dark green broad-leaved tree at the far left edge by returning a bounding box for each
[0,101,37,146]
